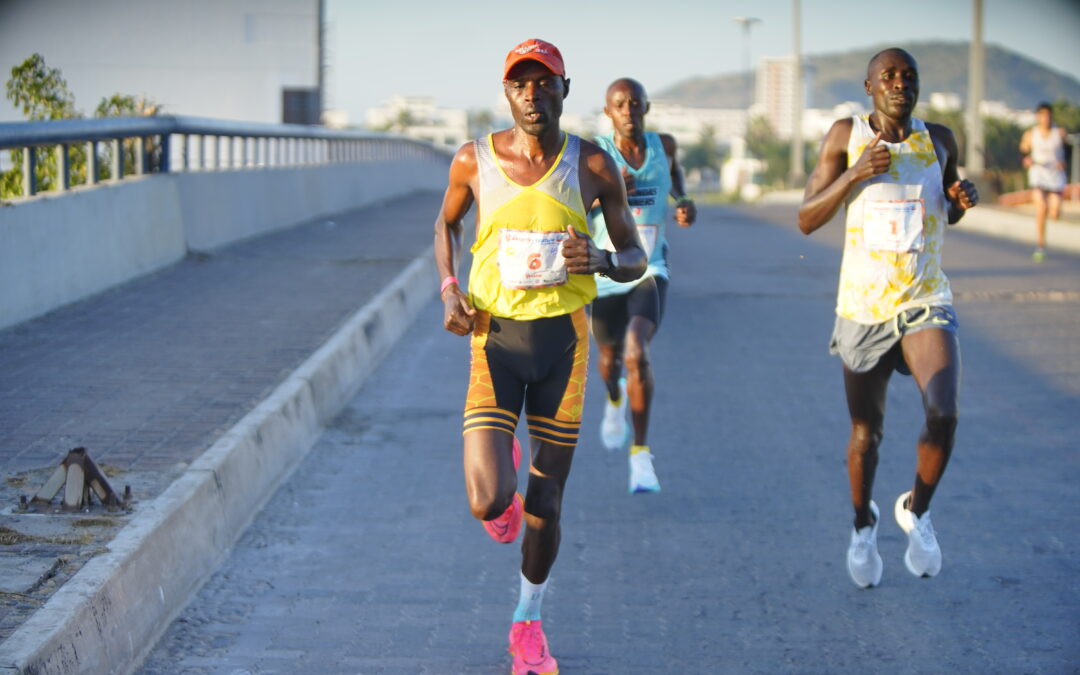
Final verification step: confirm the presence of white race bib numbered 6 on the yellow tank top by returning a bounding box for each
[497,229,570,288]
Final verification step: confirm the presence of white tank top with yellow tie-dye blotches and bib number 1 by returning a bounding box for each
[836,116,953,324]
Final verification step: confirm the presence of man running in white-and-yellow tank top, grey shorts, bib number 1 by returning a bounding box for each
[799,49,978,588]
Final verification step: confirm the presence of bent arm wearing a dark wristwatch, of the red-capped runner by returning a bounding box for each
[563,140,647,282]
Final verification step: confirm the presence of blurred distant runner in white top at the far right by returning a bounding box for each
[1020,103,1065,262]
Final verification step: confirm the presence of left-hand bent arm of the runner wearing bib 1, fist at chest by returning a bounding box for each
[799,120,891,234]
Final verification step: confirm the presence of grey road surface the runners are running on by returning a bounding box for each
[143,207,1080,675]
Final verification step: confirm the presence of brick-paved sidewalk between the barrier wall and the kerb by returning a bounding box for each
[0,187,438,640]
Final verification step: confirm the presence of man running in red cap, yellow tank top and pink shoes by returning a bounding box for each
[435,40,646,675]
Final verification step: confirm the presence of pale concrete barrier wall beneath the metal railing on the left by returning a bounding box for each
[0,155,449,328]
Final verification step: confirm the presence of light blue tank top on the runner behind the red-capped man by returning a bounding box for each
[589,132,672,297]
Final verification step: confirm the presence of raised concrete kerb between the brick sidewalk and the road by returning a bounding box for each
[0,248,438,675]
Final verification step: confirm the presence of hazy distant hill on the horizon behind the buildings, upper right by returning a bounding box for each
[653,41,1080,109]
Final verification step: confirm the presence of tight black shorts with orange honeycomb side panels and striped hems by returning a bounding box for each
[463,309,589,447]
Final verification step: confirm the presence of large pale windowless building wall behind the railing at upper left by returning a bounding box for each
[0,0,319,122]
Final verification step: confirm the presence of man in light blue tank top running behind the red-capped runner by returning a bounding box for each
[590,78,698,492]
